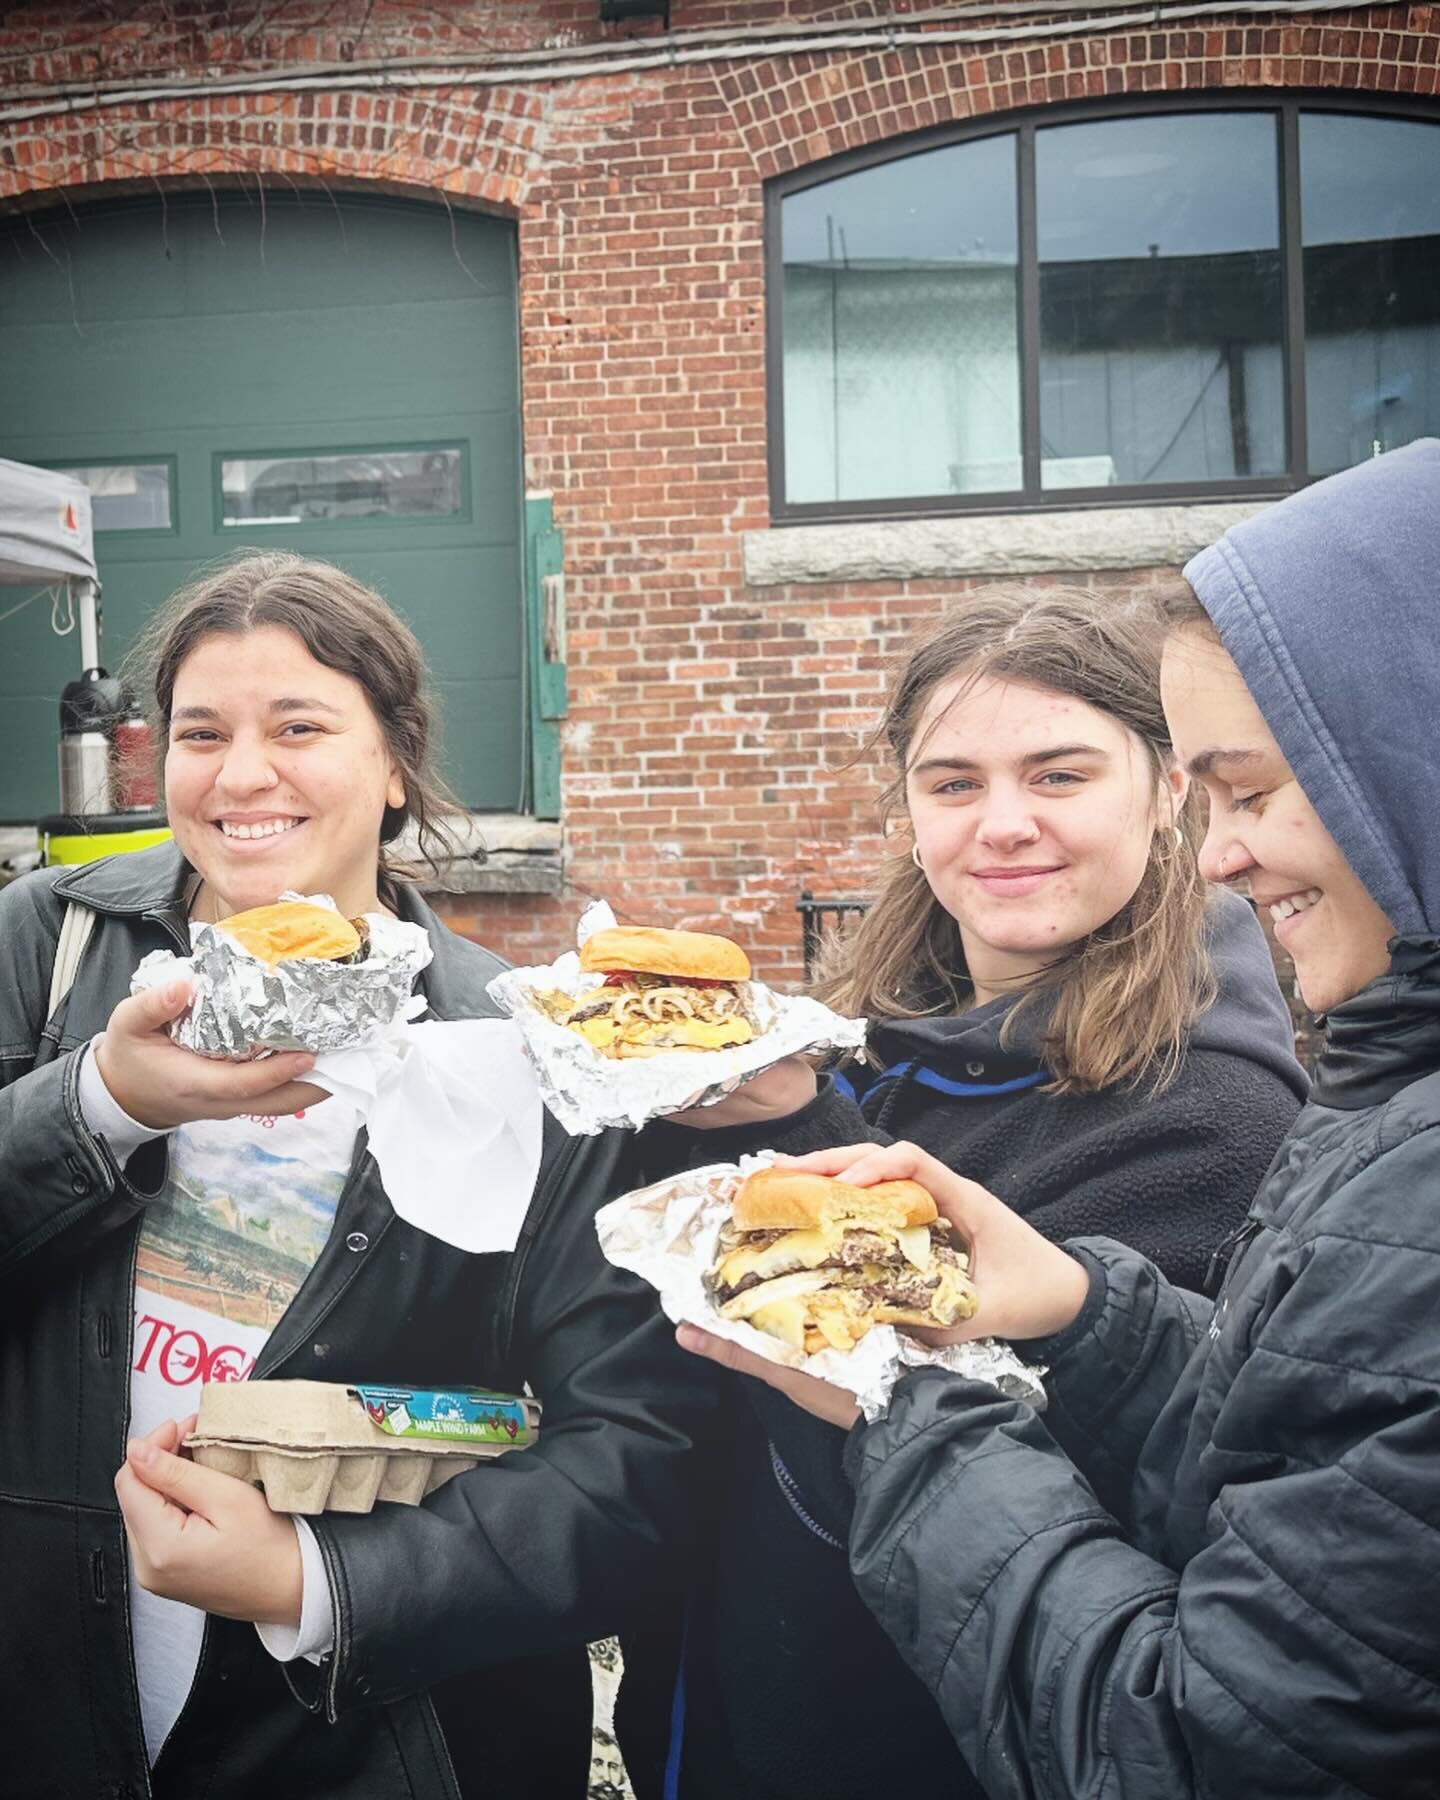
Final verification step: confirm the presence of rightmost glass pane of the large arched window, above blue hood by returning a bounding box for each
[1300,113,1440,475]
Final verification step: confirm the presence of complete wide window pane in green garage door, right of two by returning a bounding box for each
[220,446,464,526]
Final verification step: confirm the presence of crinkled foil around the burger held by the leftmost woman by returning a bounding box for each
[130,893,434,1058]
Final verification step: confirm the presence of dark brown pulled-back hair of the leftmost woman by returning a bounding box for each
[126,551,461,877]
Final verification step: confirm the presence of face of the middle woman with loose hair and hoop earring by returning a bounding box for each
[905,675,1184,1001]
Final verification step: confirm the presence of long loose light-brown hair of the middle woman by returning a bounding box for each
[819,589,1215,1093]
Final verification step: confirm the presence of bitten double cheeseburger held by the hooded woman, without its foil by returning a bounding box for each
[706,1168,977,1355]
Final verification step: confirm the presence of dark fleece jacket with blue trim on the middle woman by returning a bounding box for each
[619,895,1307,1800]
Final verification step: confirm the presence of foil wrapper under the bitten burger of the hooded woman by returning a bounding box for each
[596,1152,1046,1420]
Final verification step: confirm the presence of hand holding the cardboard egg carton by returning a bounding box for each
[115,1418,304,1625]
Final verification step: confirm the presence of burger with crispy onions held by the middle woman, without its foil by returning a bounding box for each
[536,925,756,1057]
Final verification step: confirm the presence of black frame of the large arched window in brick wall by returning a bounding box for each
[763,88,1440,526]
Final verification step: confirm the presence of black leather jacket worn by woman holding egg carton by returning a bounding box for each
[0,846,709,1800]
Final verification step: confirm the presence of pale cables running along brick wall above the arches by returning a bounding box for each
[0,0,1399,124]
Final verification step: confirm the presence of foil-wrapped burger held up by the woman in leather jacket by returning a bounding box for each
[130,895,434,1060]
